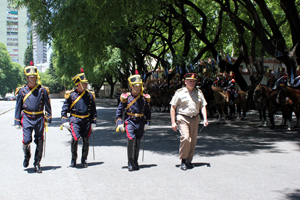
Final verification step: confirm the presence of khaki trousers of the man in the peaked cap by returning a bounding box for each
[177,115,199,163]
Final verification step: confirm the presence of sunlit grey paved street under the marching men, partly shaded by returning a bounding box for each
[0,99,300,200]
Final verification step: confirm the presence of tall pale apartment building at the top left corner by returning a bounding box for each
[0,0,27,66]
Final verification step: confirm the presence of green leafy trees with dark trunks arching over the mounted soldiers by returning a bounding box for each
[13,0,300,97]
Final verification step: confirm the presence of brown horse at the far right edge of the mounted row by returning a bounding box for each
[278,86,300,127]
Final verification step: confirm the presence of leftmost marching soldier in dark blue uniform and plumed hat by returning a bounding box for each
[15,61,52,173]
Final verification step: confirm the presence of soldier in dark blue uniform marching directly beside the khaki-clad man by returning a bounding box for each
[116,72,151,171]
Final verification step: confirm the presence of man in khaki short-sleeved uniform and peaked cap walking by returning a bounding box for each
[170,73,208,170]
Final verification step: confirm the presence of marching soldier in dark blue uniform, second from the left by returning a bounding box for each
[61,69,97,168]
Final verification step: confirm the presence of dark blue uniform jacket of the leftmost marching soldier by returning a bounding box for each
[15,85,52,125]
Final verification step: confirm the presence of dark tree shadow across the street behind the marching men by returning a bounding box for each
[50,104,300,156]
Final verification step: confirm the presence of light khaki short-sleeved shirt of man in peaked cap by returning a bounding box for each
[170,87,207,117]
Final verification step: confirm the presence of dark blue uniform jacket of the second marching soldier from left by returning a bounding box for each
[61,90,97,124]
